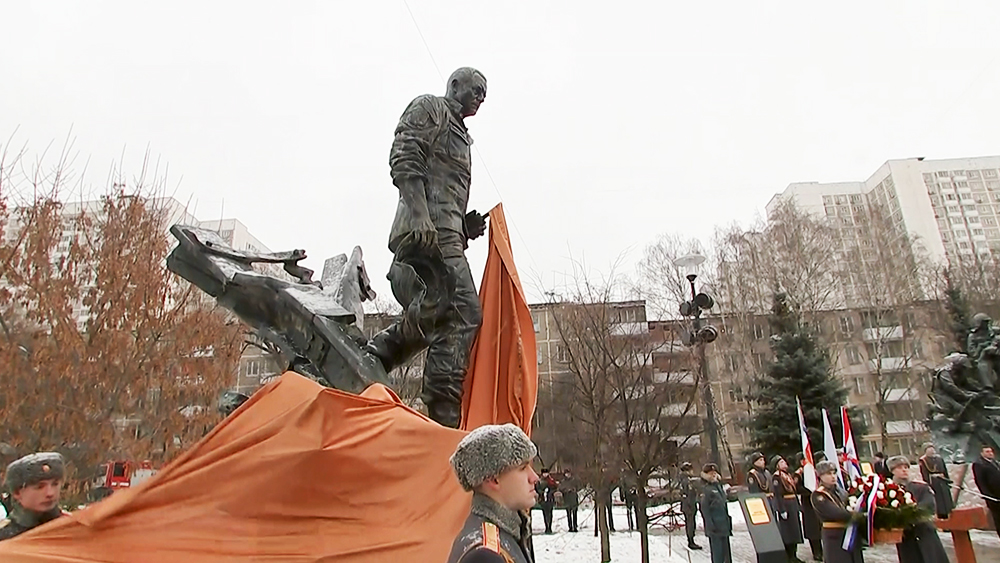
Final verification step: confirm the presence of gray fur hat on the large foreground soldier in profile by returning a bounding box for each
[451,424,538,491]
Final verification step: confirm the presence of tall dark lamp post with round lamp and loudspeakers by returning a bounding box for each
[674,254,722,476]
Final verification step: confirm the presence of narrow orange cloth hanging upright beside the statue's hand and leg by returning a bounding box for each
[462,204,538,436]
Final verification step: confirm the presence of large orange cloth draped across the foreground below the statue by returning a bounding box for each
[0,373,471,563]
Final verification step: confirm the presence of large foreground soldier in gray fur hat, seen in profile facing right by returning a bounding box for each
[448,424,538,563]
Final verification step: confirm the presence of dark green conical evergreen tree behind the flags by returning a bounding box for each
[750,293,866,460]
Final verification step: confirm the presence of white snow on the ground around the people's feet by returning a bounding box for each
[532,502,1000,563]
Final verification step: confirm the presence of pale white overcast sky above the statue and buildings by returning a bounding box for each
[0,0,1000,300]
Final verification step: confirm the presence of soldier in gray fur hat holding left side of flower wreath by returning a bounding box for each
[812,461,865,563]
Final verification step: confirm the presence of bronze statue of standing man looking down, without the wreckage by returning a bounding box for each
[366,68,486,428]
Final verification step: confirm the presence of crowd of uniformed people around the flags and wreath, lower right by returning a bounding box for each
[680,444,1000,563]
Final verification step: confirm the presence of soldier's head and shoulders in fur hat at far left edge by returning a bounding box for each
[0,452,68,540]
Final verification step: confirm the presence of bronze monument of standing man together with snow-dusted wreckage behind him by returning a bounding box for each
[167,67,486,428]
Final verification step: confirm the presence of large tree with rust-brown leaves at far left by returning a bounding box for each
[0,148,241,500]
